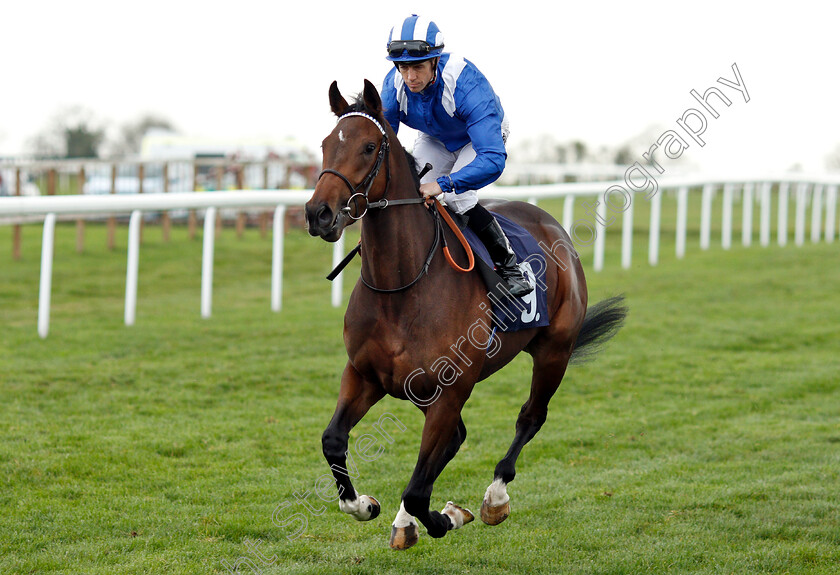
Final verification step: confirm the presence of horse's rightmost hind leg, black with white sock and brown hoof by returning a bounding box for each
[481,353,571,525]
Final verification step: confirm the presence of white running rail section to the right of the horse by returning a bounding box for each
[486,174,840,271]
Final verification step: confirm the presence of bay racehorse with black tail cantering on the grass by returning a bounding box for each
[305,80,627,549]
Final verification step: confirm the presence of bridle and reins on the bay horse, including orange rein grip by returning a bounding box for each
[318,112,475,294]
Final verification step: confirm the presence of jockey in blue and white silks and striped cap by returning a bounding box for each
[382,14,533,297]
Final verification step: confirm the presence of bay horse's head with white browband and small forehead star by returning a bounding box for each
[306,80,390,242]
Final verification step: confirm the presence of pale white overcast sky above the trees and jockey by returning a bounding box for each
[0,0,840,172]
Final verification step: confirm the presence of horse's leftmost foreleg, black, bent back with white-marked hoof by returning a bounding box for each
[321,362,385,521]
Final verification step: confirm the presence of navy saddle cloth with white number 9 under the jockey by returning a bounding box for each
[456,212,550,331]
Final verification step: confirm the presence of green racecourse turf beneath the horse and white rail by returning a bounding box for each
[0,208,840,574]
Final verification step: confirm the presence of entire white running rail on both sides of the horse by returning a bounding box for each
[0,170,840,338]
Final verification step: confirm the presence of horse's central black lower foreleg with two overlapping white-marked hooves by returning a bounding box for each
[391,404,474,549]
